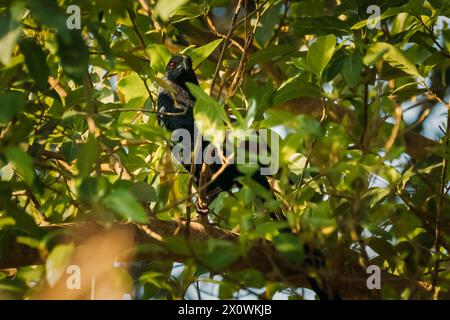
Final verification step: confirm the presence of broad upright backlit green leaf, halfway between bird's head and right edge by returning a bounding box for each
[306,35,336,78]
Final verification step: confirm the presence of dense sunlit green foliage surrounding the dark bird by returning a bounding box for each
[0,0,450,299]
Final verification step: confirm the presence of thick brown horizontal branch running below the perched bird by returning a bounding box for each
[0,218,428,299]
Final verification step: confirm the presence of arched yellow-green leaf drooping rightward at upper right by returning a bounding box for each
[364,42,419,77]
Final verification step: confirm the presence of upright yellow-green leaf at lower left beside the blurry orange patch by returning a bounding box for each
[45,243,75,287]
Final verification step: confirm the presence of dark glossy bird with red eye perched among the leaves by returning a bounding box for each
[157,54,271,213]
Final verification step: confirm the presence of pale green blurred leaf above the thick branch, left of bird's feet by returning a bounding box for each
[103,189,149,223]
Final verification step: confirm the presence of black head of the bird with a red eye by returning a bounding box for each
[166,54,198,88]
